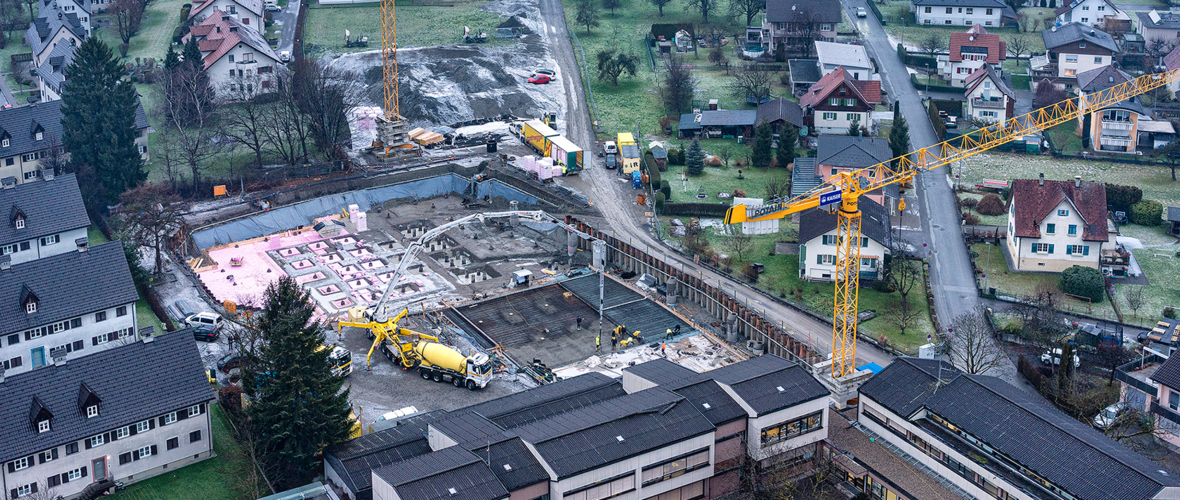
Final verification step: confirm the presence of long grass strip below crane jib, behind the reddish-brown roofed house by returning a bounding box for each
[962,152,1180,206]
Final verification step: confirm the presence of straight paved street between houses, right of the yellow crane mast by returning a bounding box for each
[841,0,1022,387]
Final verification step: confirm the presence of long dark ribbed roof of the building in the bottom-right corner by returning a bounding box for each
[926,374,1180,500]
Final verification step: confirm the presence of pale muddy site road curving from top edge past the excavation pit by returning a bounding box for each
[540,0,887,366]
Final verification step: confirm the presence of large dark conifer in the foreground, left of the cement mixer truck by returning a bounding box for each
[242,273,350,489]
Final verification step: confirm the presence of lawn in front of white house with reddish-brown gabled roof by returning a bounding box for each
[971,243,1114,317]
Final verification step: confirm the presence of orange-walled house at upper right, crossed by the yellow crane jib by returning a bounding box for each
[1077,66,1146,153]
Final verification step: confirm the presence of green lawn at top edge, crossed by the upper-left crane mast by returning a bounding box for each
[303,1,504,55]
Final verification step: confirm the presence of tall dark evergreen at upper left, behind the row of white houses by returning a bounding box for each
[61,37,148,211]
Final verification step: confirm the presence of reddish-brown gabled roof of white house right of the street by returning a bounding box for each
[1012,179,1109,242]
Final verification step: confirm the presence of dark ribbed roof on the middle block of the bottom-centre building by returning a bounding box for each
[512,387,714,479]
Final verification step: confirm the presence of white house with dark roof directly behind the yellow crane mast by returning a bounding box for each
[799,197,891,282]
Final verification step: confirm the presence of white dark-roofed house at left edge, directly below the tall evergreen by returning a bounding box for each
[0,173,90,265]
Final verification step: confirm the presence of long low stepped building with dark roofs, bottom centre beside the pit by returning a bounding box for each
[325,355,828,500]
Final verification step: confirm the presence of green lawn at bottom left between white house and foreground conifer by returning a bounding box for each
[110,404,254,500]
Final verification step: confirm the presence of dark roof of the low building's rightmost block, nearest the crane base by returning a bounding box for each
[702,354,828,415]
